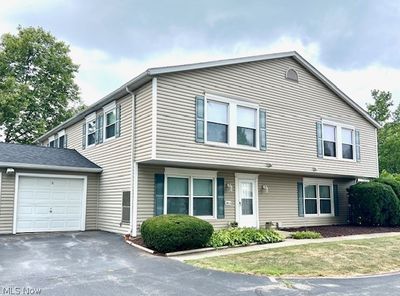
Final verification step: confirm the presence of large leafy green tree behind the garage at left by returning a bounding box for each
[0,26,82,143]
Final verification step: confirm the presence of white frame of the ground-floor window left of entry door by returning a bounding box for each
[164,168,217,220]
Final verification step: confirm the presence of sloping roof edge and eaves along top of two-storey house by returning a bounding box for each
[37,51,381,141]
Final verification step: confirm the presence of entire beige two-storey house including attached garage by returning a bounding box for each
[0,52,379,235]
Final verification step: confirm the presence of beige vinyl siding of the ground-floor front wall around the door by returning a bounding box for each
[138,164,353,231]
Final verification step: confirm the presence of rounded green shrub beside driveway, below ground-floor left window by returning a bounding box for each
[140,215,214,253]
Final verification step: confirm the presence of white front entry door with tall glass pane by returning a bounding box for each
[236,178,257,227]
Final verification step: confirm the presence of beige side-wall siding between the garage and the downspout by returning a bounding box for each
[66,96,132,233]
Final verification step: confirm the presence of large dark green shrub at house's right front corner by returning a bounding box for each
[349,182,400,226]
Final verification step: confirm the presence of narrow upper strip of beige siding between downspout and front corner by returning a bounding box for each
[135,82,152,161]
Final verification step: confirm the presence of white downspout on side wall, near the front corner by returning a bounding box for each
[125,87,138,236]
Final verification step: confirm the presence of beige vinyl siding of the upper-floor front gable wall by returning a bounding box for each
[156,58,378,177]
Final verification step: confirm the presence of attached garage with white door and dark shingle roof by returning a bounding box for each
[0,143,102,234]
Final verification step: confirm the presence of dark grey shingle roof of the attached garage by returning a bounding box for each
[0,143,102,173]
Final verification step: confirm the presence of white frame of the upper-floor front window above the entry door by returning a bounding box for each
[204,94,260,150]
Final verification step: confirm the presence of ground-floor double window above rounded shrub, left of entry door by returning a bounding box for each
[164,169,216,218]
